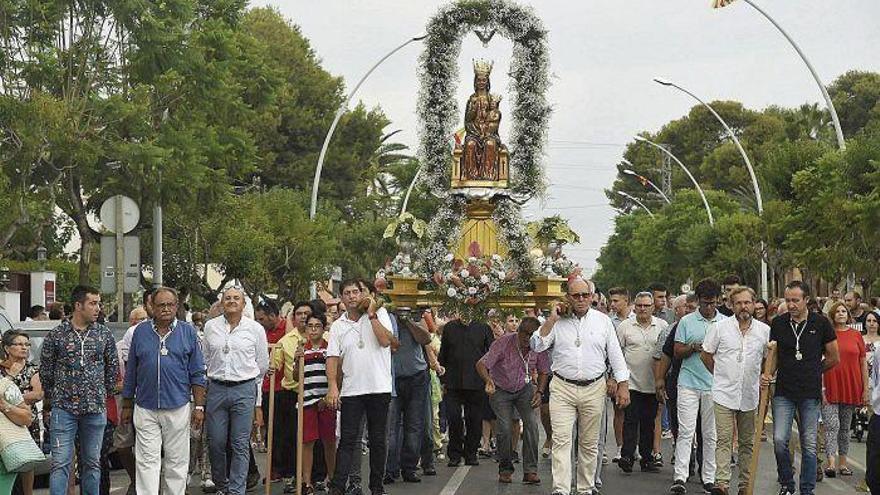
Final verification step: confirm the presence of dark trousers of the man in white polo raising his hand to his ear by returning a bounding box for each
[330,394,391,493]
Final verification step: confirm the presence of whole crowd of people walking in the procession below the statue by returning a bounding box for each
[0,277,880,495]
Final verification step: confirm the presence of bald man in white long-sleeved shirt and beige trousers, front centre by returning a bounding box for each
[531,278,630,495]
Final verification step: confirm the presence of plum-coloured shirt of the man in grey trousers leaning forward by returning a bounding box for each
[480,333,550,393]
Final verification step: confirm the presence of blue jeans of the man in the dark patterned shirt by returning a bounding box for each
[49,408,107,495]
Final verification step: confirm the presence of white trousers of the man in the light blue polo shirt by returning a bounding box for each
[675,386,717,483]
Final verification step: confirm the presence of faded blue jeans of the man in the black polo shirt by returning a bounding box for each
[773,395,821,495]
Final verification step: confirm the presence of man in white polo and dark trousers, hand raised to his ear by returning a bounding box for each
[327,280,394,495]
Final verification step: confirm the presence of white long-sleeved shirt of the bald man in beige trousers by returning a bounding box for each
[531,308,629,382]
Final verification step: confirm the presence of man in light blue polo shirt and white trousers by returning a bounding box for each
[670,279,726,494]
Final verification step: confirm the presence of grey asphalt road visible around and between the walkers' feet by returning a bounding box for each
[36,410,865,495]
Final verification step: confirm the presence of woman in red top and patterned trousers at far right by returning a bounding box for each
[822,302,869,478]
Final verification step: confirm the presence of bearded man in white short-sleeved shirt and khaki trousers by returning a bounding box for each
[700,286,770,495]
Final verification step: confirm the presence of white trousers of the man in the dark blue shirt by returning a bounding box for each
[134,404,190,495]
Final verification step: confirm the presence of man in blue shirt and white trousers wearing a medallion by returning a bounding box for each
[122,287,206,495]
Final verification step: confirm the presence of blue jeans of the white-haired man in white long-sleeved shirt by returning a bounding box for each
[205,380,259,495]
